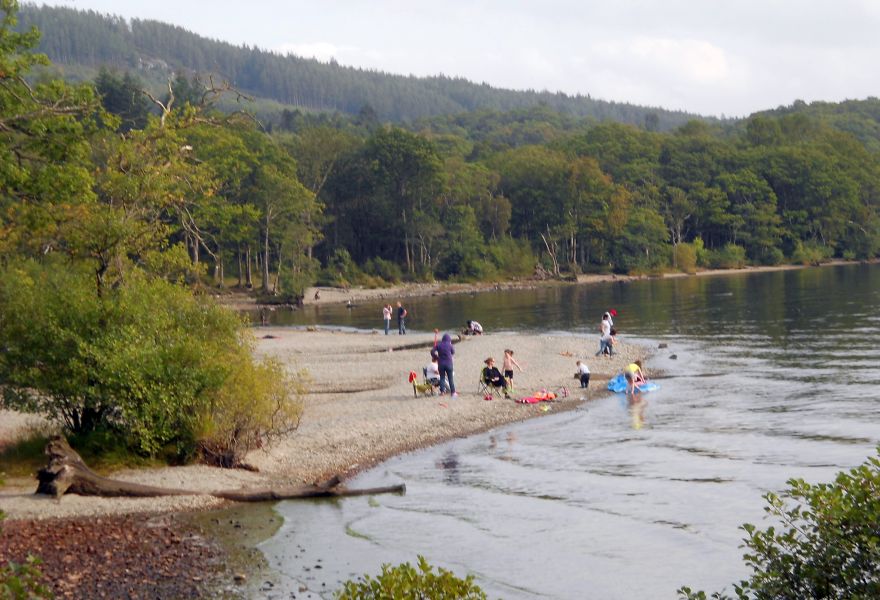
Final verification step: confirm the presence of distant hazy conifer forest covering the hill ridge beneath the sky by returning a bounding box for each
[19,5,696,130]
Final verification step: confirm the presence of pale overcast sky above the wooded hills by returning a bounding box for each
[47,0,880,116]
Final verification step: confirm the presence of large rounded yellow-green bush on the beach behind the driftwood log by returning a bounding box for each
[0,261,300,466]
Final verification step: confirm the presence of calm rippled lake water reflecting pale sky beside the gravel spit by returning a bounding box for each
[261,265,880,599]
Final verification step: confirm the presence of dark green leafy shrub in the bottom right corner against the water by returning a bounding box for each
[679,447,880,600]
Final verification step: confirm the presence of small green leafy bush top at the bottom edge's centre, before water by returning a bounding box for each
[336,555,486,600]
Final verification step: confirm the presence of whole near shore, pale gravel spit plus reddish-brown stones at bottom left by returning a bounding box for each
[0,327,650,597]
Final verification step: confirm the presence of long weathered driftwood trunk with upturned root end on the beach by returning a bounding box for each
[36,436,406,502]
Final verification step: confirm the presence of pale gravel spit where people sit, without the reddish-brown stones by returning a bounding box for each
[0,327,645,519]
